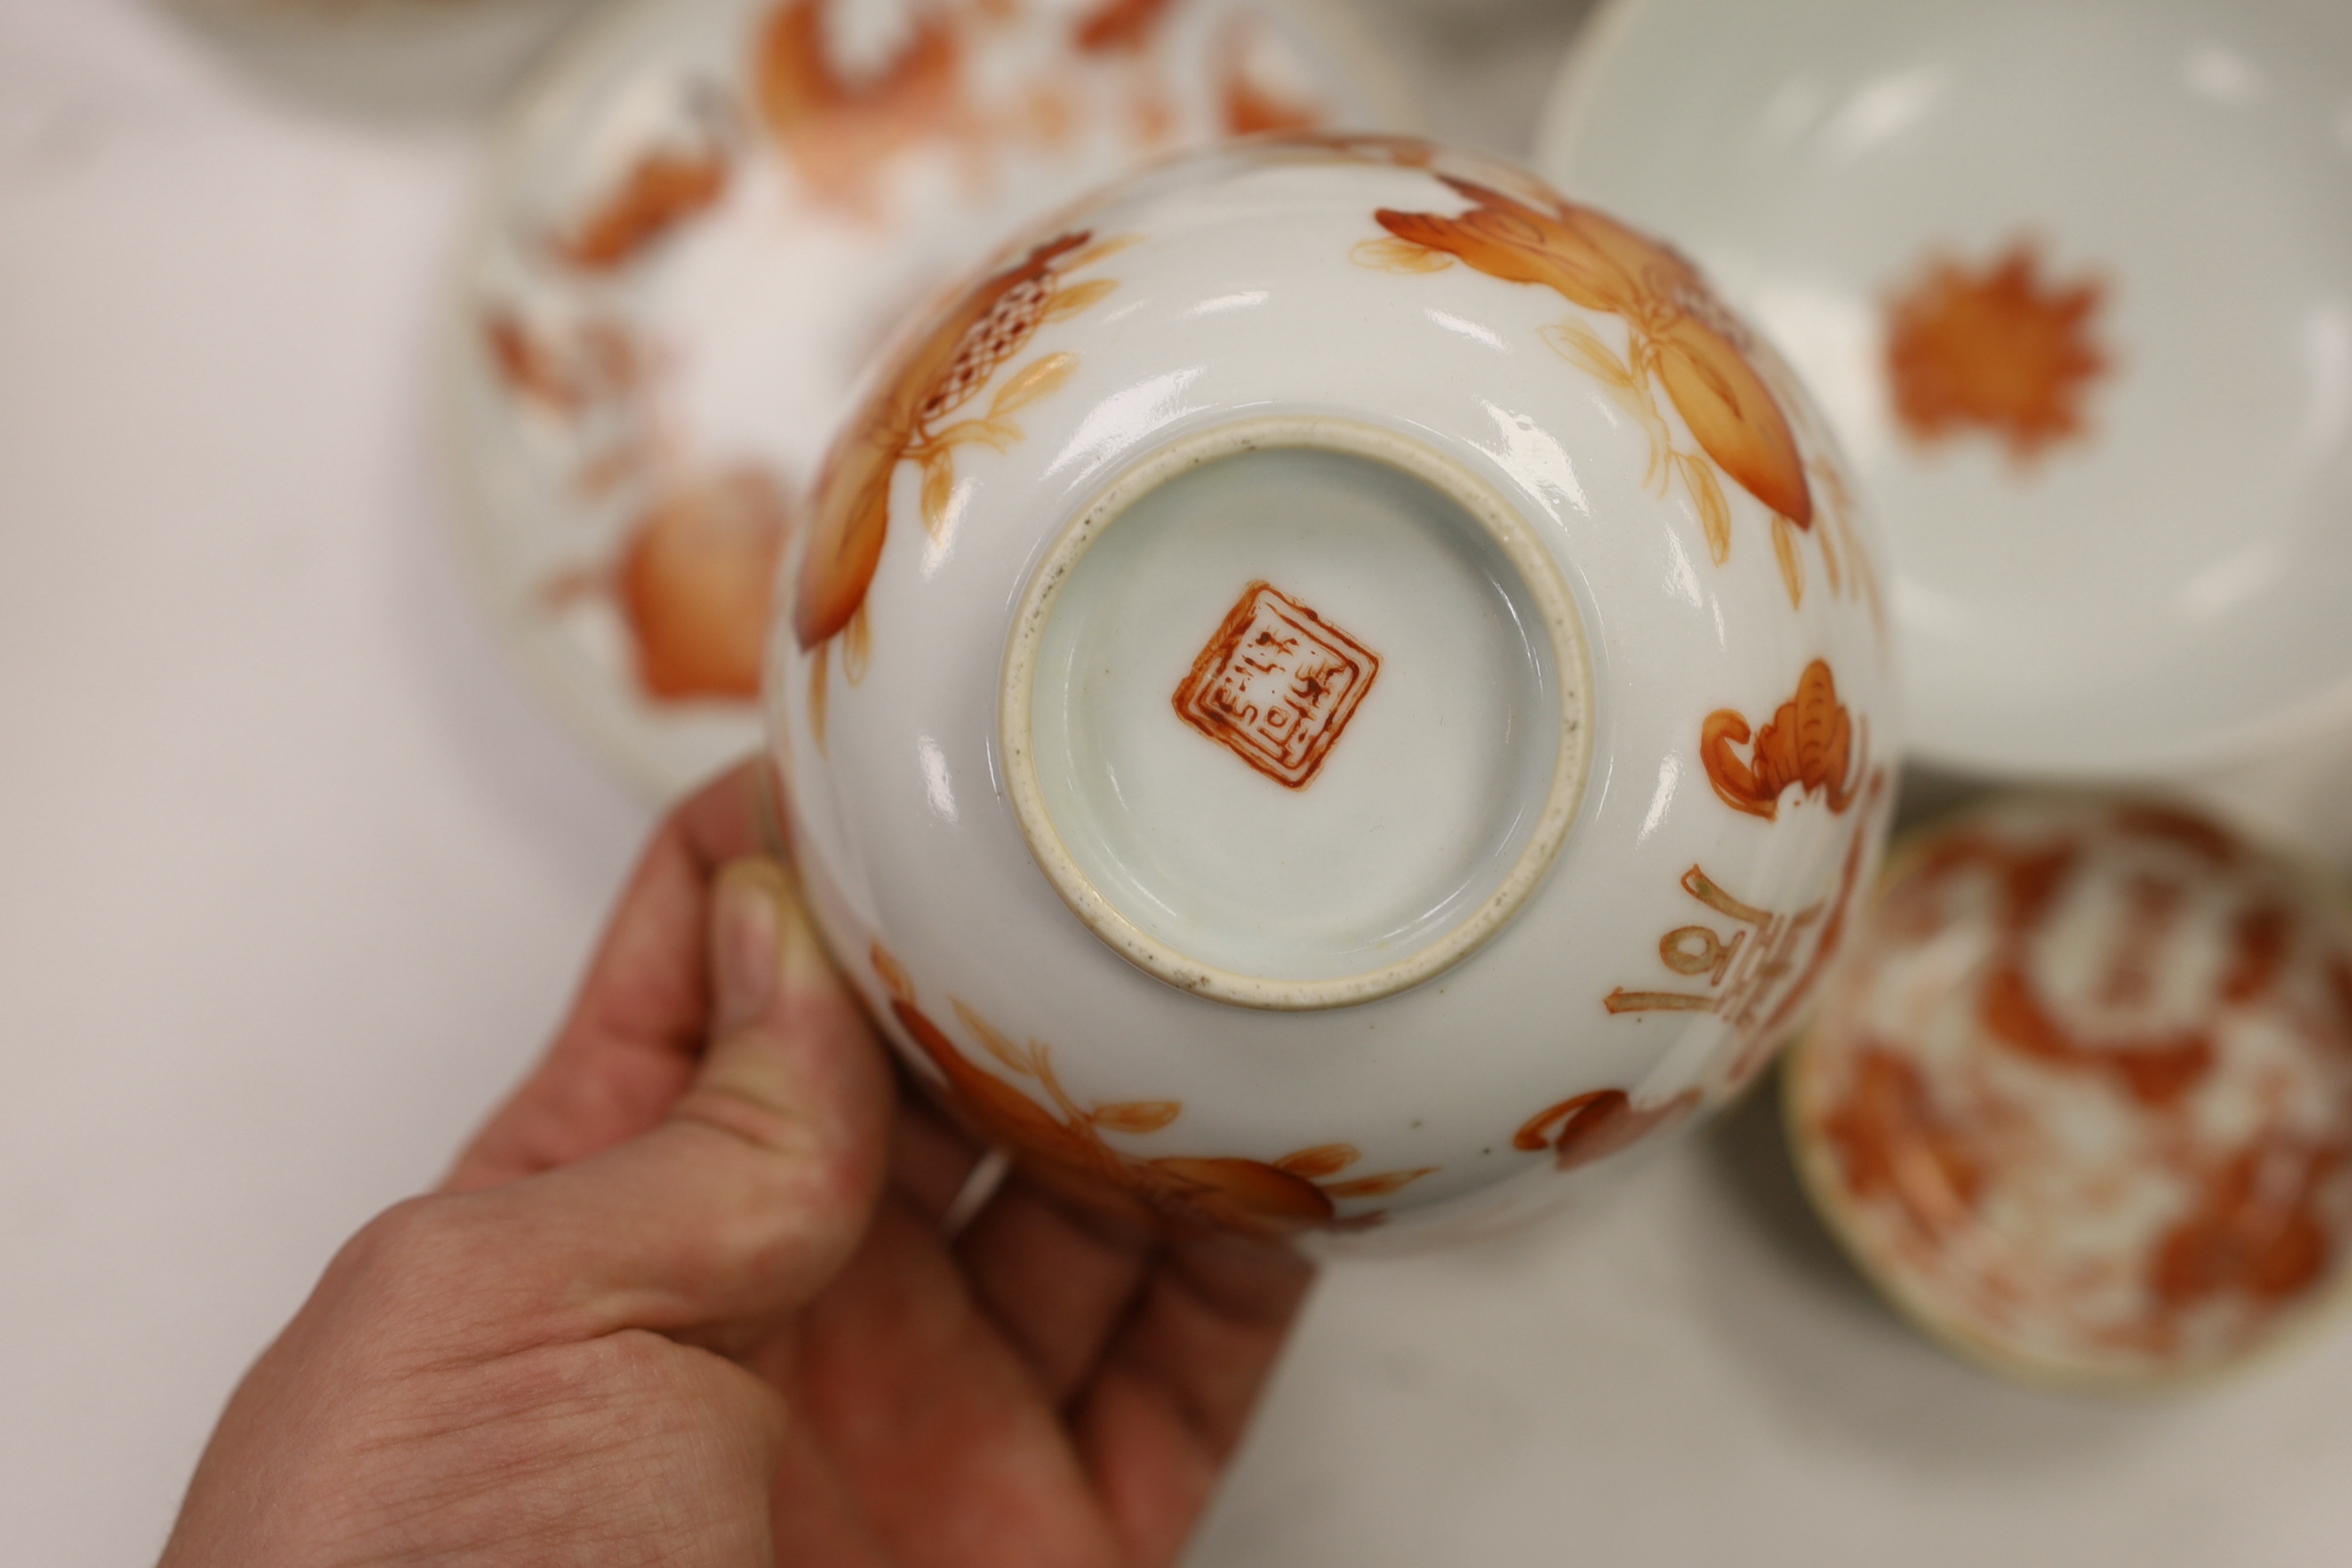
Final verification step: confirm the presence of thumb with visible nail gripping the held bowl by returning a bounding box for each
[470,860,892,1349]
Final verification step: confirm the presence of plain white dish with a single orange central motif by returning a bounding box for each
[1536,0,2352,776]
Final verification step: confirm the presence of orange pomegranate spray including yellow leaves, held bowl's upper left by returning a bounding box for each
[793,230,1132,743]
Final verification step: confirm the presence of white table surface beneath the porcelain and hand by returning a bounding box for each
[0,0,2352,1568]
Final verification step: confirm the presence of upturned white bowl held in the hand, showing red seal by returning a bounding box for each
[767,136,1898,1230]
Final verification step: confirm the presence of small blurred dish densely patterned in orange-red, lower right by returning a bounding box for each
[1783,799,2352,1387]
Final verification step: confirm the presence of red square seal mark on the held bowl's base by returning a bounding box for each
[1176,583,1380,790]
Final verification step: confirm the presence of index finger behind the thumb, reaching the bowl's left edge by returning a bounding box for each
[442,759,778,1192]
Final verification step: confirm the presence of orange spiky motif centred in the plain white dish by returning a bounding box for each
[1886,240,2110,466]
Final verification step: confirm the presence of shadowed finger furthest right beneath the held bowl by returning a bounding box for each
[1072,1239,1315,1563]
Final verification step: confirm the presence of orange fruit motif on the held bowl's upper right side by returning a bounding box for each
[1373,174,1813,527]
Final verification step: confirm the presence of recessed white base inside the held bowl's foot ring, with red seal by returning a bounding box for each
[1007,421,1578,1007]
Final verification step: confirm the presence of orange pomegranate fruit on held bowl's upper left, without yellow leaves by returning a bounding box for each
[793,233,1091,649]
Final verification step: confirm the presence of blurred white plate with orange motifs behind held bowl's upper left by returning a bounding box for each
[447,0,1409,797]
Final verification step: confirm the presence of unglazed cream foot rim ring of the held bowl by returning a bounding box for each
[997,413,1593,1010]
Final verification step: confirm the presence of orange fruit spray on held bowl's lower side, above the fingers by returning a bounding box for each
[870,945,1437,1236]
